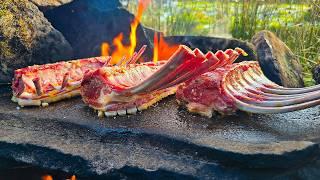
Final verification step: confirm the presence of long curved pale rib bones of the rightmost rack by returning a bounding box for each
[223,62,320,113]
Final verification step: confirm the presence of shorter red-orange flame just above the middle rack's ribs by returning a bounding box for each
[153,33,179,62]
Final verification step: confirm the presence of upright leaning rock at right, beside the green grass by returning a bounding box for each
[252,31,304,87]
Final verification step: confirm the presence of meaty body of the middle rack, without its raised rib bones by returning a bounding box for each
[81,62,176,116]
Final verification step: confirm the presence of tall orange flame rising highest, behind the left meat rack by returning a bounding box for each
[101,0,151,64]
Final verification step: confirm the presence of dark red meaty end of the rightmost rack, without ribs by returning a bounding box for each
[176,65,237,117]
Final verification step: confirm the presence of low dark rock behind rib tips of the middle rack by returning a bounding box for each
[161,33,256,62]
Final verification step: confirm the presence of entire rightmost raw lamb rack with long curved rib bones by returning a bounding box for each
[176,61,320,117]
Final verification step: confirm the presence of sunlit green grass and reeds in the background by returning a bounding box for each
[122,0,320,85]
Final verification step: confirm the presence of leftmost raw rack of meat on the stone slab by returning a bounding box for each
[12,57,110,106]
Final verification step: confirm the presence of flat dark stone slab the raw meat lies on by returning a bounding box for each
[0,87,320,178]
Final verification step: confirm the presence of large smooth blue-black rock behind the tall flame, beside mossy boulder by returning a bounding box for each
[45,0,150,58]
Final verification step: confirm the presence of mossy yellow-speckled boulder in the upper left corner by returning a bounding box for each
[0,0,72,83]
